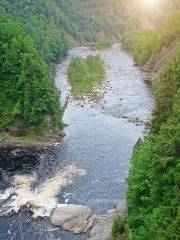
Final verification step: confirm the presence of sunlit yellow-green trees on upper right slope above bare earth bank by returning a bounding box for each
[122,10,180,65]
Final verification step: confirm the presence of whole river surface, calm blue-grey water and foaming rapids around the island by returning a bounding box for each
[0,44,153,240]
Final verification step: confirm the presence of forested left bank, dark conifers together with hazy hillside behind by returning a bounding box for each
[0,0,136,142]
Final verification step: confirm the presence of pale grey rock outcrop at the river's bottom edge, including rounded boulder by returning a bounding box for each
[50,201,127,240]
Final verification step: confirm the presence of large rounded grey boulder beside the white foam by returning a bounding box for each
[50,204,95,233]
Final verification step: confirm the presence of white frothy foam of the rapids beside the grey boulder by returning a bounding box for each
[0,165,86,218]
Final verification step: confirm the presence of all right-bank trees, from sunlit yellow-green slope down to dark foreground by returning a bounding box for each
[124,11,180,240]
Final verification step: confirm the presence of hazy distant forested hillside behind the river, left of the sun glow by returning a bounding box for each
[0,0,133,63]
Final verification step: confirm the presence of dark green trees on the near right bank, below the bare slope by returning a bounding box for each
[127,46,180,240]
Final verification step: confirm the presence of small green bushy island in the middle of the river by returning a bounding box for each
[68,56,104,95]
